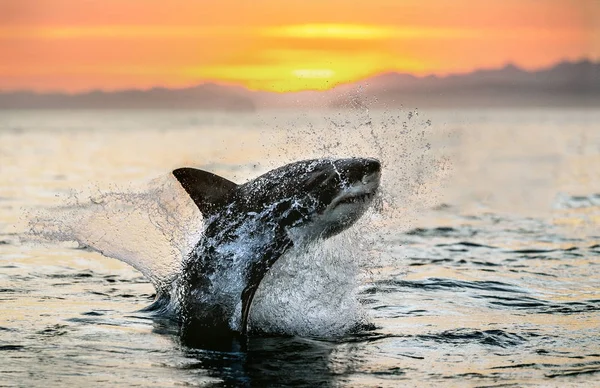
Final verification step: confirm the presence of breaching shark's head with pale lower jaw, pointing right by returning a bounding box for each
[239,158,381,239]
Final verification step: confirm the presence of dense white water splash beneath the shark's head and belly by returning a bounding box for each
[250,229,368,338]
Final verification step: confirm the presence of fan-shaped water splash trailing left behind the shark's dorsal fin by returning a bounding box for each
[30,174,202,290]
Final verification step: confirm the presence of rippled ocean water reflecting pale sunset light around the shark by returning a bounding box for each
[0,108,600,387]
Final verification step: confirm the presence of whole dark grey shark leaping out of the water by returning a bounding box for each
[166,158,381,338]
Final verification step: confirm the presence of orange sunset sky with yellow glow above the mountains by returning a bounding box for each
[0,0,600,92]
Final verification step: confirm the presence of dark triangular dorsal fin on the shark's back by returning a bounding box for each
[173,167,238,217]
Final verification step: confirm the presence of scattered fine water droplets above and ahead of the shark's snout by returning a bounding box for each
[267,100,452,229]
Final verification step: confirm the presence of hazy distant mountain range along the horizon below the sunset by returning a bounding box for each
[0,60,600,111]
